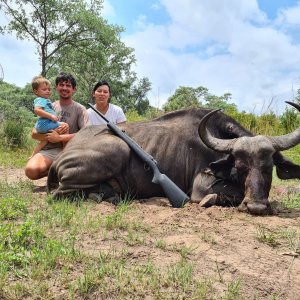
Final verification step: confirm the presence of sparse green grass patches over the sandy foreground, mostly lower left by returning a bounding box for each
[0,139,299,300]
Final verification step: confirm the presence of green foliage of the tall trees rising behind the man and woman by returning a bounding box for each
[0,0,151,115]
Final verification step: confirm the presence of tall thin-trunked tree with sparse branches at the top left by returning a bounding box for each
[0,0,105,76]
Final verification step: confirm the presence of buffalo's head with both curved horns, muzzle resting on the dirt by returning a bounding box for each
[198,103,300,215]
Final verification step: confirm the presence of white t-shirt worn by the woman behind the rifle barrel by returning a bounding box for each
[87,103,126,125]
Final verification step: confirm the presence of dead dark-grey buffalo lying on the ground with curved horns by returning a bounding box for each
[47,103,300,214]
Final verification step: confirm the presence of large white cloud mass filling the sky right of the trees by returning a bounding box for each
[121,0,300,113]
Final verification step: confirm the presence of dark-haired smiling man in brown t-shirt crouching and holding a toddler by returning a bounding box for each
[25,73,89,180]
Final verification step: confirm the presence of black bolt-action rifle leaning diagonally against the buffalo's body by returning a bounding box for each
[88,103,189,208]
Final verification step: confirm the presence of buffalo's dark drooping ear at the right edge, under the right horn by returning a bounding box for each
[273,152,300,179]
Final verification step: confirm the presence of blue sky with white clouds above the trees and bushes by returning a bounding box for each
[0,0,300,114]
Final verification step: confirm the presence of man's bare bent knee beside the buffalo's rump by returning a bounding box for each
[25,153,53,180]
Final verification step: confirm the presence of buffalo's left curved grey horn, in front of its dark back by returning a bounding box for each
[198,109,237,154]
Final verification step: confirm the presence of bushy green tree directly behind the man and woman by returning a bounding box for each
[53,18,137,106]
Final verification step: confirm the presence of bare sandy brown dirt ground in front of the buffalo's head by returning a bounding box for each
[0,167,300,300]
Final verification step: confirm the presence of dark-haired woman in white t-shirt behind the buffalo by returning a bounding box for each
[87,80,126,125]
